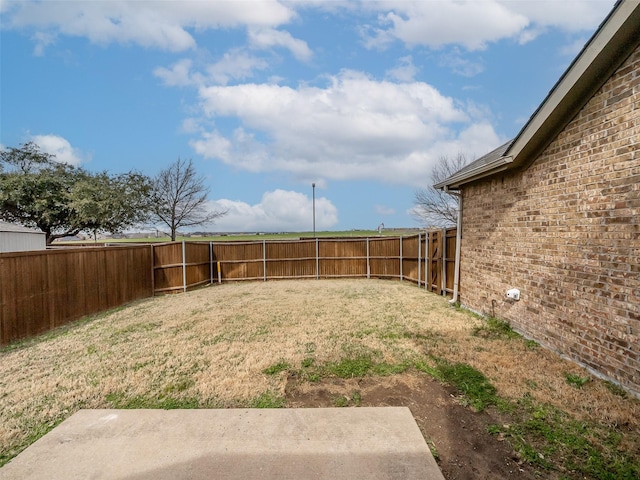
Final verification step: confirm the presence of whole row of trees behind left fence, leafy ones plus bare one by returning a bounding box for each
[0,142,226,245]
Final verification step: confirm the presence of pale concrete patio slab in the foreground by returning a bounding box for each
[0,407,444,480]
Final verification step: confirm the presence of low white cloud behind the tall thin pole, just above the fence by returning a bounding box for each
[211,190,338,232]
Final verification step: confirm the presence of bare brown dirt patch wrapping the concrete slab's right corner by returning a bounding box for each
[286,373,539,480]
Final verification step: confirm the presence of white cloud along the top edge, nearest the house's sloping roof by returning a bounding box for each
[360,0,614,50]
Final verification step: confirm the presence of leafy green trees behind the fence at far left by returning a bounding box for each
[0,142,151,245]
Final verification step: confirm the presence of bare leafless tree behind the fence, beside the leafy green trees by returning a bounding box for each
[152,158,227,242]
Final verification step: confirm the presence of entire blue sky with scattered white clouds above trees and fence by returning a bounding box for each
[0,0,614,231]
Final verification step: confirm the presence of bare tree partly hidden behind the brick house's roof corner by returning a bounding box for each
[412,153,469,227]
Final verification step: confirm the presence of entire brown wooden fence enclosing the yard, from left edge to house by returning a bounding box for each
[0,229,456,345]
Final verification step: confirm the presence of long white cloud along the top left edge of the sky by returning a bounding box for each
[3,0,295,52]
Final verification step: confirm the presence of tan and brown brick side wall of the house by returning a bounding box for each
[461,45,640,394]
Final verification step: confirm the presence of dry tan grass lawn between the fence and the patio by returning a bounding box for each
[0,280,640,470]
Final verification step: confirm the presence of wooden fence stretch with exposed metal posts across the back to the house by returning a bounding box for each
[152,229,456,294]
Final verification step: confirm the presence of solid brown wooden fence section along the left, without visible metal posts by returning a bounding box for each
[0,246,153,345]
